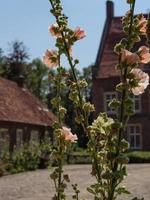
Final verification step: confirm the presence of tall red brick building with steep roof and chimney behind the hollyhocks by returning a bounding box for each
[92,1,150,151]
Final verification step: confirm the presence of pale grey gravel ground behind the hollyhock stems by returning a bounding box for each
[0,164,150,200]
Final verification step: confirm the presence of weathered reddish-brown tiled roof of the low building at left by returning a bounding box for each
[0,78,56,126]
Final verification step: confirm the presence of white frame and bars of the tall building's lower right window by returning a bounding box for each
[127,124,142,150]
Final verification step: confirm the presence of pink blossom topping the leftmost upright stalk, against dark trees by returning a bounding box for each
[43,49,58,68]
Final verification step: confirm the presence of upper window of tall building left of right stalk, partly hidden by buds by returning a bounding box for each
[104,92,116,114]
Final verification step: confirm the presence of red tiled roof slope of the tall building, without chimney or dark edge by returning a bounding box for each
[96,17,124,78]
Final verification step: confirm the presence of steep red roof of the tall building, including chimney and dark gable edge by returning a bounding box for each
[93,1,150,78]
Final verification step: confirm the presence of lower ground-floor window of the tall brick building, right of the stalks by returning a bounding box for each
[127,124,142,149]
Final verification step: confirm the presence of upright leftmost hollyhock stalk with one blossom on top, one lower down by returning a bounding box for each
[44,31,77,200]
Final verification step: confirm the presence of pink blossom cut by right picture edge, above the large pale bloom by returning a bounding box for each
[138,46,150,64]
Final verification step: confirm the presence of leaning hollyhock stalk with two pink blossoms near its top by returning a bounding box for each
[49,0,94,134]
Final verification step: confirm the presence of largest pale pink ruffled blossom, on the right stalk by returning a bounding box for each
[131,68,149,95]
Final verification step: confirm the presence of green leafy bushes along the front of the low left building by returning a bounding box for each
[0,138,52,173]
